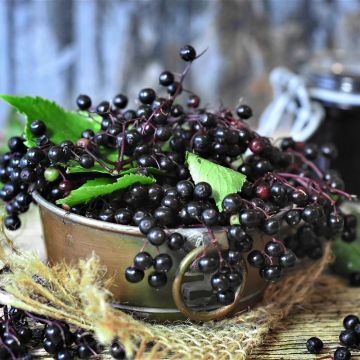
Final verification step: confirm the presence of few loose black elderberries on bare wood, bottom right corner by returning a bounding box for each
[306,314,360,360]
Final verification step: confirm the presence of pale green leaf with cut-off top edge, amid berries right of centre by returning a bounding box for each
[186,152,246,211]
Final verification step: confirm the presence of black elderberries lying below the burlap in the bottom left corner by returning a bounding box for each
[0,306,126,360]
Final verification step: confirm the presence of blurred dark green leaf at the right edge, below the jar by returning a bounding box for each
[332,209,360,276]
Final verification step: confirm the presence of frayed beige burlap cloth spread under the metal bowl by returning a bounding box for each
[0,225,331,360]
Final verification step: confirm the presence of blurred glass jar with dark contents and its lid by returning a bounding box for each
[303,51,360,196]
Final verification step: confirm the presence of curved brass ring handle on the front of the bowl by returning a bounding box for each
[172,246,248,321]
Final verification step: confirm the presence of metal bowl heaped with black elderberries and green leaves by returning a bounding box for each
[0,45,356,321]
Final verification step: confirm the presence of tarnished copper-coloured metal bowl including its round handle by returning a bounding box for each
[33,192,269,321]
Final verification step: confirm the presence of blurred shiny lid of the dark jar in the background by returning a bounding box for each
[303,50,360,108]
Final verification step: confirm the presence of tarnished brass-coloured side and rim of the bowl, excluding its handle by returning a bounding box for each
[33,193,266,320]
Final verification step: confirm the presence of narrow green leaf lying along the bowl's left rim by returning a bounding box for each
[56,174,156,206]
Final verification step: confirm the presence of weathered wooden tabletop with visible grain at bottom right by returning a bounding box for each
[249,275,360,360]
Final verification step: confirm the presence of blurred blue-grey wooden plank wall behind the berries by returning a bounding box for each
[0,0,360,122]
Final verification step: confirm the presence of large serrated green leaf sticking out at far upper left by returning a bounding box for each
[0,95,100,147]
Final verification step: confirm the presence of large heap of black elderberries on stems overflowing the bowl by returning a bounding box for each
[0,45,356,310]
